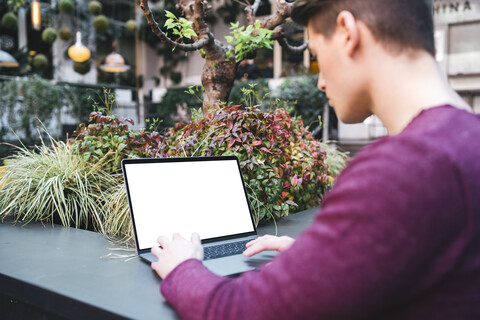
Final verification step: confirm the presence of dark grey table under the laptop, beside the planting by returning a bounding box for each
[0,209,316,319]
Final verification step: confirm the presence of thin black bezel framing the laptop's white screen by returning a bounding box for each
[122,156,257,254]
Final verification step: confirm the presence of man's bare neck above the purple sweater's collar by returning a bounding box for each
[371,52,470,135]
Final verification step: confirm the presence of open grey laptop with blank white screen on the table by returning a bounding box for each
[122,156,275,276]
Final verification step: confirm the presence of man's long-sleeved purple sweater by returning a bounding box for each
[161,106,480,320]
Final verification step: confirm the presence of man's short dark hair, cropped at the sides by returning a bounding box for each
[291,0,435,56]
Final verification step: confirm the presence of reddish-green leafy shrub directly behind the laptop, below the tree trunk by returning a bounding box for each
[165,106,333,222]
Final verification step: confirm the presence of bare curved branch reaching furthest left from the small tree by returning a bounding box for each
[140,0,213,51]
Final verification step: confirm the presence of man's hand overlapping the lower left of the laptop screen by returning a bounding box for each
[151,233,203,279]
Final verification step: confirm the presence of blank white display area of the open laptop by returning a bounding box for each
[124,160,255,250]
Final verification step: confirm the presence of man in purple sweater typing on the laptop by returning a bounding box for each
[152,0,480,320]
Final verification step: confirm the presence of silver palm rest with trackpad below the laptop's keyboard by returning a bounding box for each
[203,251,277,276]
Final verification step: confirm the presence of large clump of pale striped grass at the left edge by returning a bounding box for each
[0,140,121,233]
